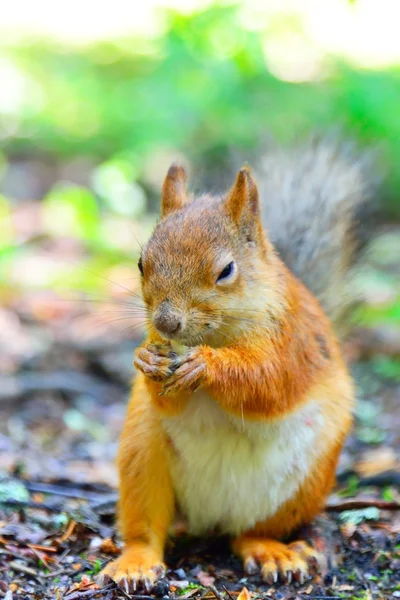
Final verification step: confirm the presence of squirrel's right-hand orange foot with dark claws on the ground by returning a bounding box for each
[233,536,324,585]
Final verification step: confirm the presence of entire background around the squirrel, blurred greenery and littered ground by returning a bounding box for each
[0,0,400,600]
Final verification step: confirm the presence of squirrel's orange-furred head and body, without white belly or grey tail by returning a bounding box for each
[98,167,353,582]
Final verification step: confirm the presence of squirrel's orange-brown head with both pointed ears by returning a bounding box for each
[138,165,279,346]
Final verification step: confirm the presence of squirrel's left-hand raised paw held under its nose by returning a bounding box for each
[134,344,177,382]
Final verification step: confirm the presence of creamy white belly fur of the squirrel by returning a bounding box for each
[164,391,323,534]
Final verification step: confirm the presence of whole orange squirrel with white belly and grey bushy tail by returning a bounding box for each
[100,142,371,591]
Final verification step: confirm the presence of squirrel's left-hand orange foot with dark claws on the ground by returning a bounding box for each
[97,544,165,594]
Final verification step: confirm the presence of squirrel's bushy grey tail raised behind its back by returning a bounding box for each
[258,141,378,326]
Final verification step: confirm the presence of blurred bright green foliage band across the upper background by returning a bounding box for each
[0,5,400,211]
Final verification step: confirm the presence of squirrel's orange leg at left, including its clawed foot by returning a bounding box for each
[102,374,174,588]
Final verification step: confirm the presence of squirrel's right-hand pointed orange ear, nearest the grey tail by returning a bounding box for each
[225,167,260,241]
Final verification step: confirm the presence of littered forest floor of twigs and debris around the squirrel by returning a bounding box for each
[0,227,400,600]
